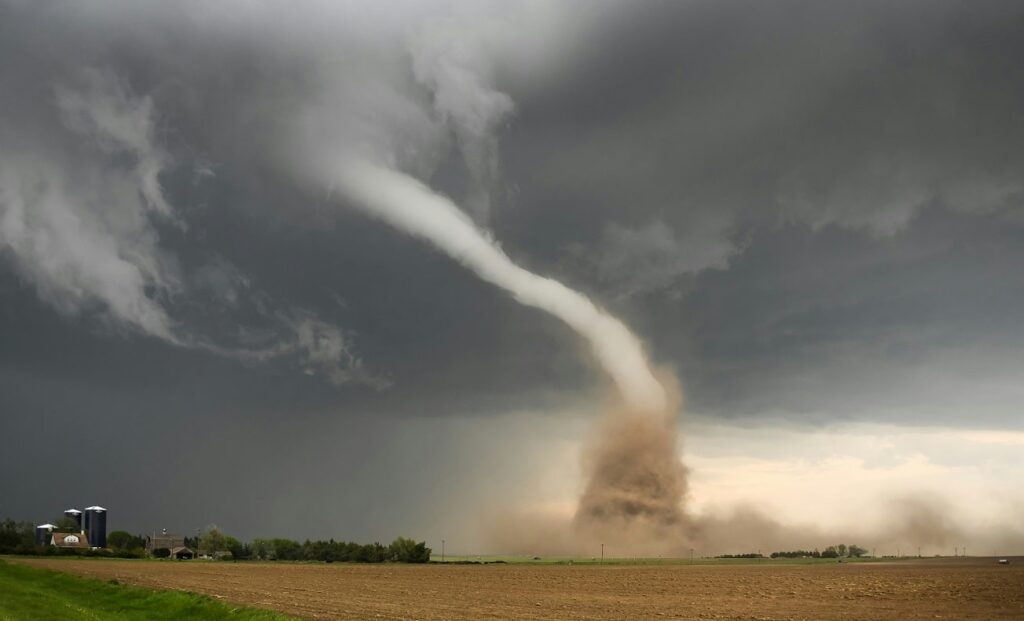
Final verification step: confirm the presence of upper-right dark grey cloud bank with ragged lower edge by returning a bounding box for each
[505,2,1024,261]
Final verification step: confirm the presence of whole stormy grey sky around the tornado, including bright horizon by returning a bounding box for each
[0,0,1024,546]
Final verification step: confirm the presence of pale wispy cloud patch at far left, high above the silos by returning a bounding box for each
[0,70,180,342]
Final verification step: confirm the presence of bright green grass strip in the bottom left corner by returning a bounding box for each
[0,560,291,621]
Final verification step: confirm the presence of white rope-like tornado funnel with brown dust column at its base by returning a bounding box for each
[331,160,686,539]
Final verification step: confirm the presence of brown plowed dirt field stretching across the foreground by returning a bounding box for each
[12,558,1024,621]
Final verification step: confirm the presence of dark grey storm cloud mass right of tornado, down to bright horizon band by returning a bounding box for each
[487,2,1024,425]
